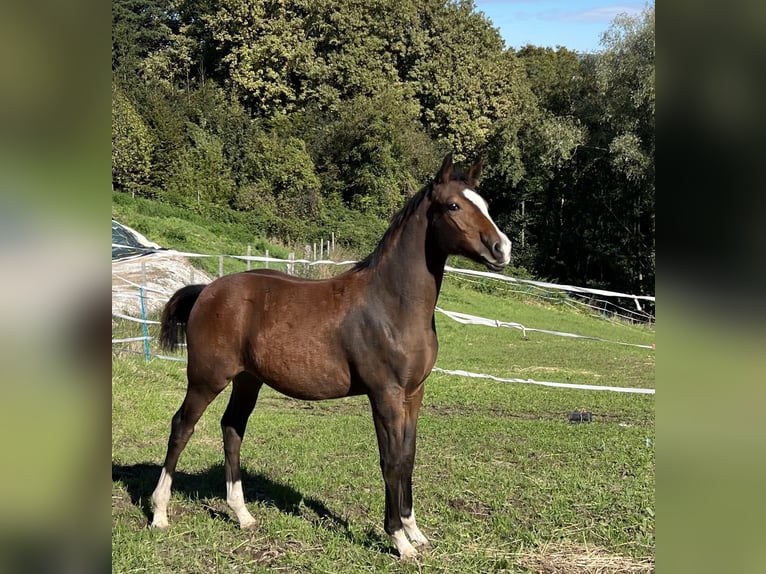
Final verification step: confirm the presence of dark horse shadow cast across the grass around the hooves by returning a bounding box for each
[112,462,388,549]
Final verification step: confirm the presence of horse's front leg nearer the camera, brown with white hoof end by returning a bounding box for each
[370,387,418,560]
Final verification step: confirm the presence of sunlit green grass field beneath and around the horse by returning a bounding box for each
[112,277,655,573]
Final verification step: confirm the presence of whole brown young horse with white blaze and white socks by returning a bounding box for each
[152,155,511,558]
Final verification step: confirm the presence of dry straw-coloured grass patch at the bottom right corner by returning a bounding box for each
[517,542,654,574]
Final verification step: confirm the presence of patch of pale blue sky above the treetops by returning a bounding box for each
[474,0,646,52]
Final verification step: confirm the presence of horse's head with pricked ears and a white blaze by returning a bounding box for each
[428,154,511,271]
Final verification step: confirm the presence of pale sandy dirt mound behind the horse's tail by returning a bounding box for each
[112,253,214,317]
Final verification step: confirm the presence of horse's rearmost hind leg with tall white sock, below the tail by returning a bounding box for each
[151,379,227,528]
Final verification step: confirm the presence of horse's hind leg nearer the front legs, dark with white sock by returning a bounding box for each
[221,372,262,528]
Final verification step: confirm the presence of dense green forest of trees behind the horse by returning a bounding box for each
[112,0,655,294]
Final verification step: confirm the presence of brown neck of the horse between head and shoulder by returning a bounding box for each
[375,201,447,321]
